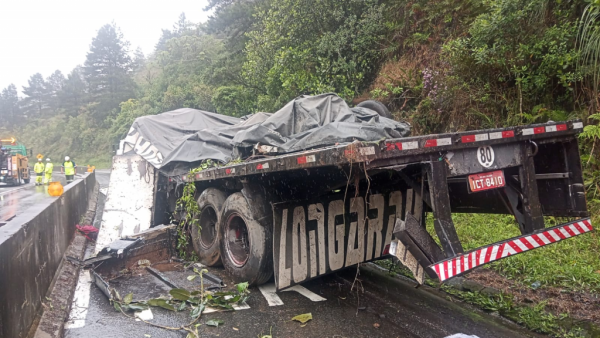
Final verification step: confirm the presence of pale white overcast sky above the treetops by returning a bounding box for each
[0,0,209,92]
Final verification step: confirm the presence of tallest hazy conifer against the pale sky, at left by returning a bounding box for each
[84,23,134,121]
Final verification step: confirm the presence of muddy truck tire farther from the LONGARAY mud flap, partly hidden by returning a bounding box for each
[191,188,226,266]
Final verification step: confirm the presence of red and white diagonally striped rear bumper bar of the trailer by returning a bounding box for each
[429,218,593,282]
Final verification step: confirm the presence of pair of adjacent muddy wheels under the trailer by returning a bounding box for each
[192,188,273,285]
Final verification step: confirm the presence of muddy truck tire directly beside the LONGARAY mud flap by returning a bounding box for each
[221,192,273,285]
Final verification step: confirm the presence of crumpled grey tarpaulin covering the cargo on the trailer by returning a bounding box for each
[123,94,410,174]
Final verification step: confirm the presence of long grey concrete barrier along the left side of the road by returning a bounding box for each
[0,173,96,338]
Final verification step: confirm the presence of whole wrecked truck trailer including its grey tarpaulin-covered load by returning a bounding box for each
[119,95,592,289]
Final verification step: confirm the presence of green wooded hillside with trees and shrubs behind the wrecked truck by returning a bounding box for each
[0,0,600,332]
